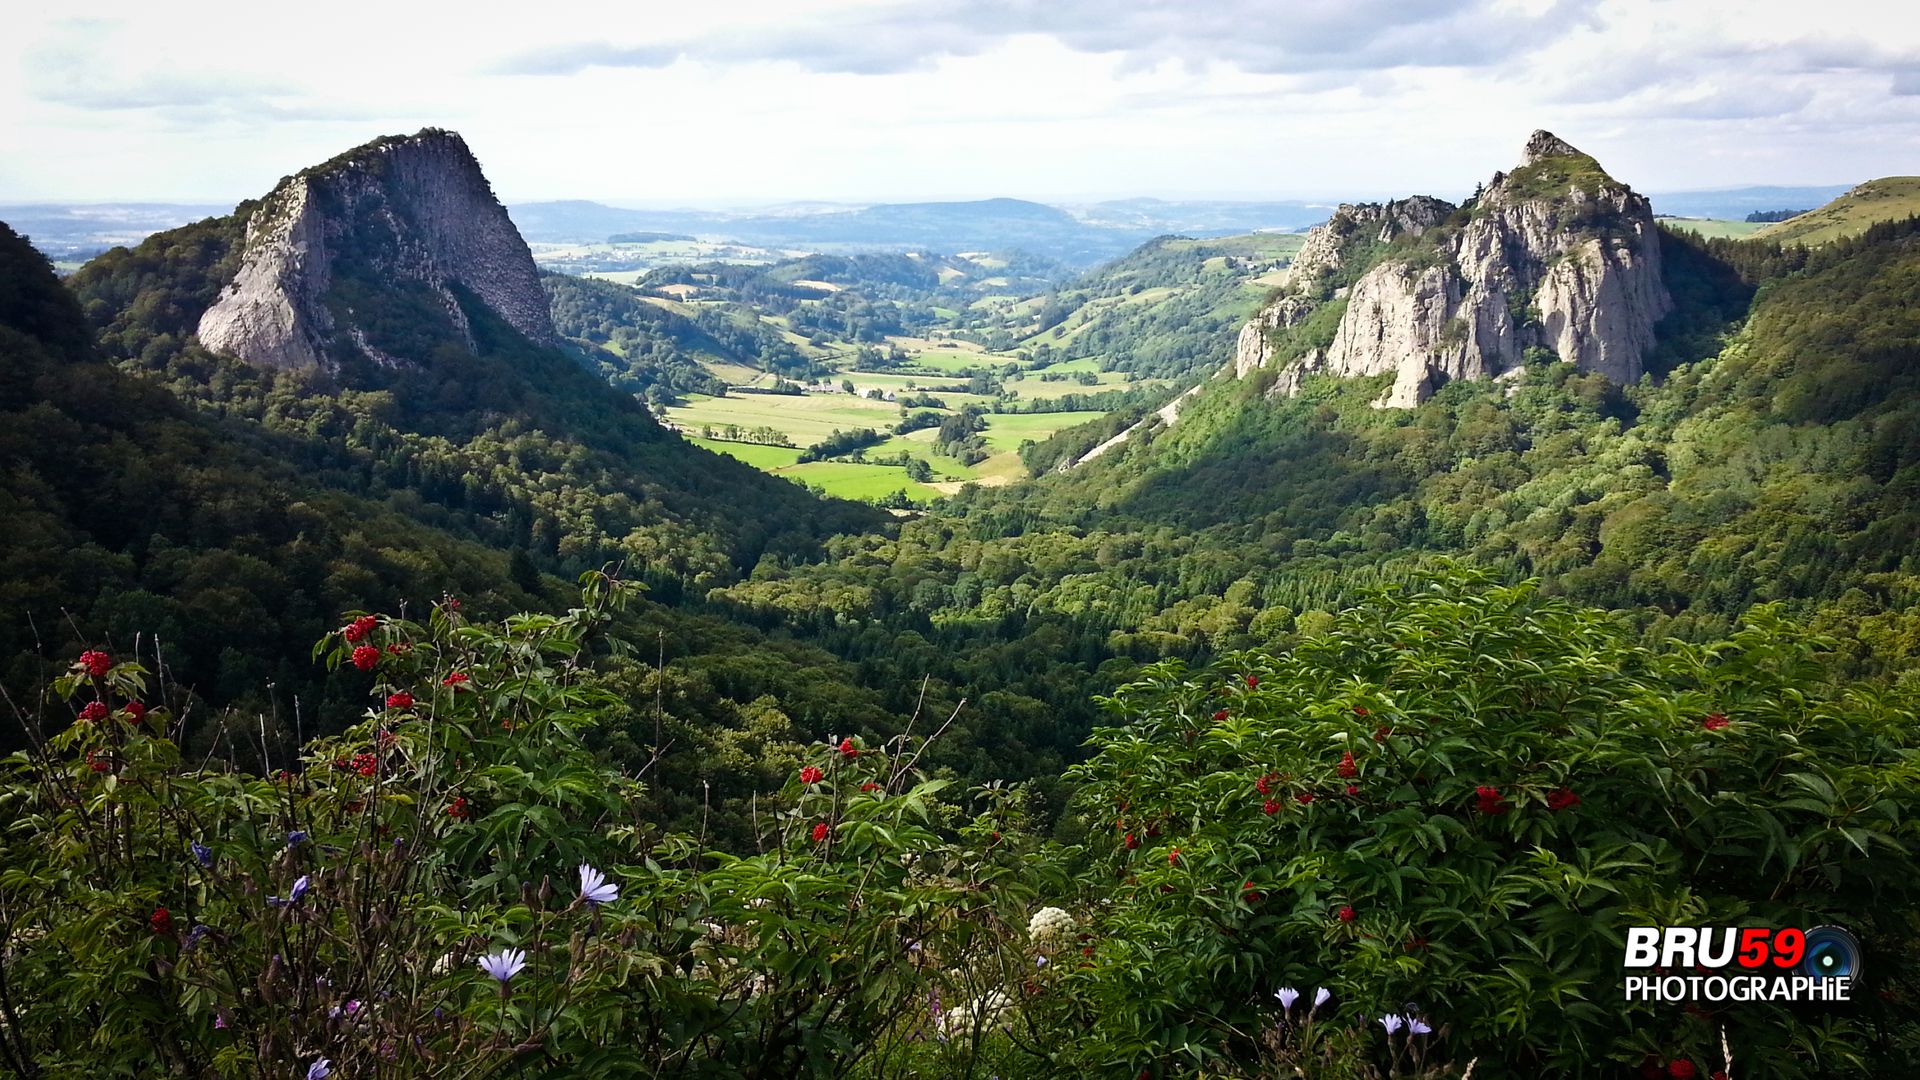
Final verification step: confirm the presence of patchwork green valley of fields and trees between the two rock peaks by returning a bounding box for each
[545,234,1300,507]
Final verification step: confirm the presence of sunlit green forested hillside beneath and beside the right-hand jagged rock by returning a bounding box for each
[730,221,1920,671]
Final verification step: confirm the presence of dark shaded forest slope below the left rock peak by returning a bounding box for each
[0,210,1112,836]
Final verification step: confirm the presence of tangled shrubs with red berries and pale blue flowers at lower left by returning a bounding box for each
[0,577,1025,1078]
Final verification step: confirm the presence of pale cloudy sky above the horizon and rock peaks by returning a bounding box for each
[0,0,1920,206]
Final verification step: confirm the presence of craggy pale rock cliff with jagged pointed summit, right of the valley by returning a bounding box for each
[1235,131,1672,407]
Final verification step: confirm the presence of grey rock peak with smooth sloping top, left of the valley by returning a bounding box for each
[200,129,557,367]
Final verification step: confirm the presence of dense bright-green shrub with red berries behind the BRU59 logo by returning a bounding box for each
[1073,573,1920,1076]
